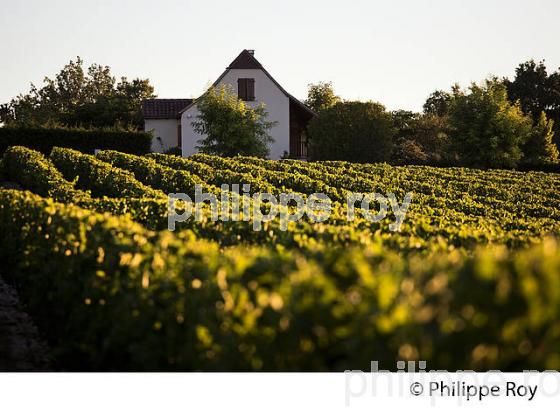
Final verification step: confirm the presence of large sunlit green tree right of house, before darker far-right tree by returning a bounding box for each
[449,79,532,168]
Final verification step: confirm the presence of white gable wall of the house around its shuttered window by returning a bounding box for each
[181,69,290,159]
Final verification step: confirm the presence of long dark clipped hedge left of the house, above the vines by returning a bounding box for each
[0,127,152,155]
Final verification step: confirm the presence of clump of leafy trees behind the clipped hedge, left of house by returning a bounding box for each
[0,57,155,128]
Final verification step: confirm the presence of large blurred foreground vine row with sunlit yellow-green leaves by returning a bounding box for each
[0,190,560,371]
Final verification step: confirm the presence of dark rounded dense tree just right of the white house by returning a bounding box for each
[308,101,395,162]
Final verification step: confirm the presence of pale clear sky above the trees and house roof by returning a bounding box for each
[0,0,560,110]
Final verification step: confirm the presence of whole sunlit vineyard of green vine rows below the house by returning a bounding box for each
[0,147,560,371]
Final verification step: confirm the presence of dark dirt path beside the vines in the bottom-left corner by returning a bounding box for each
[0,277,49,371]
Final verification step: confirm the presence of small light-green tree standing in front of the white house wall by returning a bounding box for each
[192,86,276,157]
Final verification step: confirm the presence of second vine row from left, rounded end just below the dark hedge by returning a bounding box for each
[50,147,165,198]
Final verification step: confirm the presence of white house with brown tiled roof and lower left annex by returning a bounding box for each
[143,50,314,159]
